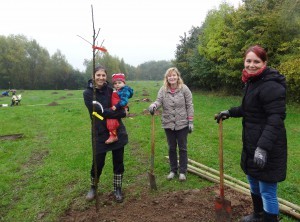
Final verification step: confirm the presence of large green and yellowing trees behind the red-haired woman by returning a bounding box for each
[174,0,300,102]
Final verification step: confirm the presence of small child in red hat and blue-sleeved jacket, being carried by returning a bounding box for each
[105,73,133,144]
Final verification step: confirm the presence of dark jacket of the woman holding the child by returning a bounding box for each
[83,80,128,154]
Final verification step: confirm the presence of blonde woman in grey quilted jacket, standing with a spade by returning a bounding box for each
[148,67,194,181]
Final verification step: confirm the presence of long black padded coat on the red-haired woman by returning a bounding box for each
[229,68,287,182]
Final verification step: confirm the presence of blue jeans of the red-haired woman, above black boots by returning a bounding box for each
[247,175,279,215]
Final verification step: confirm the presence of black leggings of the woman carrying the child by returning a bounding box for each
[91,147,124,178]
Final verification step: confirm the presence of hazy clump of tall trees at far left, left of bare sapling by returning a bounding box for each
[0,35,84,89]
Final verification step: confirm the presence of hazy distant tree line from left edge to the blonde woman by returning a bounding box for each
[0,35,171,90]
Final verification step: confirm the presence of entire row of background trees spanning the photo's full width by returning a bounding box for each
[0,0,300,102]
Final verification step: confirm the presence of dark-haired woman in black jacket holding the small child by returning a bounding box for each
[83,66,128,203]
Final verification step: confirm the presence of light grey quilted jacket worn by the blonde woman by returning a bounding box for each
[154,85,194,130]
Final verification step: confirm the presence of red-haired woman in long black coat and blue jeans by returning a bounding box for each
[216,45,287,222]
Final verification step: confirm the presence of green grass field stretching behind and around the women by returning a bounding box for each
[0,82,300,221]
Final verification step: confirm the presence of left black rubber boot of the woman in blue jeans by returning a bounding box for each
[240,193,264,222]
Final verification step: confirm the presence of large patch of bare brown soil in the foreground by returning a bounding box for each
[60,186,252,222]
